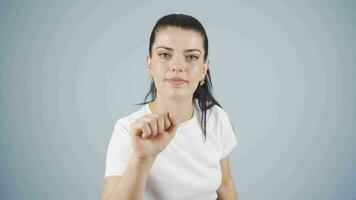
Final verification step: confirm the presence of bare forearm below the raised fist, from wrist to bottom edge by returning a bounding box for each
[108,156,155,200]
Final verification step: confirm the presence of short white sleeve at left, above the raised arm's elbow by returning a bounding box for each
[105,120,132,177]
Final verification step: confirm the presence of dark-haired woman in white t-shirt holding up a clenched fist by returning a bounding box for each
[102,14,237,200]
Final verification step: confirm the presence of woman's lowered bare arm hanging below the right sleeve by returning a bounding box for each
[217,156,237,200]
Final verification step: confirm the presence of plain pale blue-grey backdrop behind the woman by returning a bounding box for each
[0,0,356,200]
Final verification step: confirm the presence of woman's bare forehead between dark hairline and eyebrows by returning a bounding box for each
[153,27,204,51]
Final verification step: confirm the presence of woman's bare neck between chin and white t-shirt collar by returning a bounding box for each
[149,96,194,124]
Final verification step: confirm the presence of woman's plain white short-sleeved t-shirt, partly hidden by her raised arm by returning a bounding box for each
[105,102,237,200]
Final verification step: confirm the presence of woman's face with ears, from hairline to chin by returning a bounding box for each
[147,27,209,99]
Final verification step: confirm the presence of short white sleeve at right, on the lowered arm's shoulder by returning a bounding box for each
[221,110,237,158]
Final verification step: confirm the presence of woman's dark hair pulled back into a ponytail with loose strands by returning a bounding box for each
[138,14,221,139]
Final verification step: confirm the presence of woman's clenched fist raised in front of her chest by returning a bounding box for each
[130,113,178,159]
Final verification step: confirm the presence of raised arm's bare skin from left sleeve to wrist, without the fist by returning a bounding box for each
[101,156,155,200]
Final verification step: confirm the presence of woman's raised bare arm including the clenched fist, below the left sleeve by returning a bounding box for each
[101,113,178,200]
